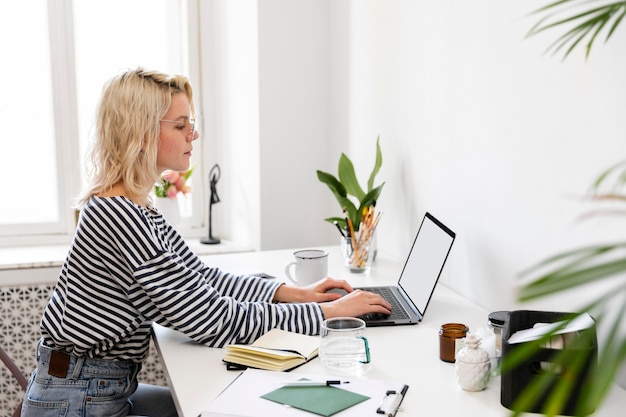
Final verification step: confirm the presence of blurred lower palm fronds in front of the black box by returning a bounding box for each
[502,161,626,416]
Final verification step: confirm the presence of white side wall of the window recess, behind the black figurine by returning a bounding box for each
[199,0,261,249]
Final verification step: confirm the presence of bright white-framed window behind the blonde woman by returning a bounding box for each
[0,0,202,244]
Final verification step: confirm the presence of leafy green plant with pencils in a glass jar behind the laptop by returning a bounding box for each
[317,137,385,272]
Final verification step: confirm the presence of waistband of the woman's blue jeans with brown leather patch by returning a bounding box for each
[37,341,141,380]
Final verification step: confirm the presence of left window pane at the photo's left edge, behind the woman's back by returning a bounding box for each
[0,0,60,234]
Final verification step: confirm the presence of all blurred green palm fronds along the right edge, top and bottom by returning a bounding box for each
[502,0,626,416]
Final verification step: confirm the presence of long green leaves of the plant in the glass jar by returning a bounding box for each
[317,136,385,231]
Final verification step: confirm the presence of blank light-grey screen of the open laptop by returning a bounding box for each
[398,213,455,315]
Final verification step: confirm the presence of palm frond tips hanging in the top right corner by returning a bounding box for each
[528,0,626,59]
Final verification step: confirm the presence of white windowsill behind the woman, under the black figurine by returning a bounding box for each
[0,238,251,271]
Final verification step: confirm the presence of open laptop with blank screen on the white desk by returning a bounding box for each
[344,212,456,327]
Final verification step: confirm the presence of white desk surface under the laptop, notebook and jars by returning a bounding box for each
[154,247,626,417]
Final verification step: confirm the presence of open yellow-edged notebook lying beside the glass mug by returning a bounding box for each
[224,329,320,371]
